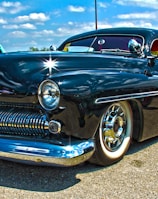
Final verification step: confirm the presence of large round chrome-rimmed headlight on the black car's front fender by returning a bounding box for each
[38,80,60,111]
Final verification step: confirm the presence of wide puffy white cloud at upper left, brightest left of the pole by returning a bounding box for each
[14,13,49,22]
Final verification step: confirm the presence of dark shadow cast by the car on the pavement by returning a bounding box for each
[0,137,158,192]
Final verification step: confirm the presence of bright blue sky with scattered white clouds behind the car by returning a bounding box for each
[0,0,158,51]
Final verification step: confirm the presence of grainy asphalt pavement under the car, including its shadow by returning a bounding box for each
[0,137,158,199]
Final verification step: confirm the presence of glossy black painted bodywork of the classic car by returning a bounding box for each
[0,28,158,141]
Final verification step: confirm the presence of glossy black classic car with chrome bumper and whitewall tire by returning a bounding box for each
[0,28,158,166]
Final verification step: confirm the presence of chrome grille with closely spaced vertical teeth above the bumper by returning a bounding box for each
[0,108,49,136]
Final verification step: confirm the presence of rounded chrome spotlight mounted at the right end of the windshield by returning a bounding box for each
[128,39,142,55]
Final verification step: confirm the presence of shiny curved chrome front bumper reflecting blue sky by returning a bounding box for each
[0,138,94,166]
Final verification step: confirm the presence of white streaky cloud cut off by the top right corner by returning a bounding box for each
[113,0,158,9]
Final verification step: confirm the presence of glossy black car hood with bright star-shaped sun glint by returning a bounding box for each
[0,52,146,95]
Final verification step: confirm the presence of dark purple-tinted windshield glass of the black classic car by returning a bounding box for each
[63,35,143,52]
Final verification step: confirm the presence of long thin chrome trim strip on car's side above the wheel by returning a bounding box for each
[95,91,158,104]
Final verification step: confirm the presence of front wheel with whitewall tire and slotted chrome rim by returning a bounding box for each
[90,101,133,166]
